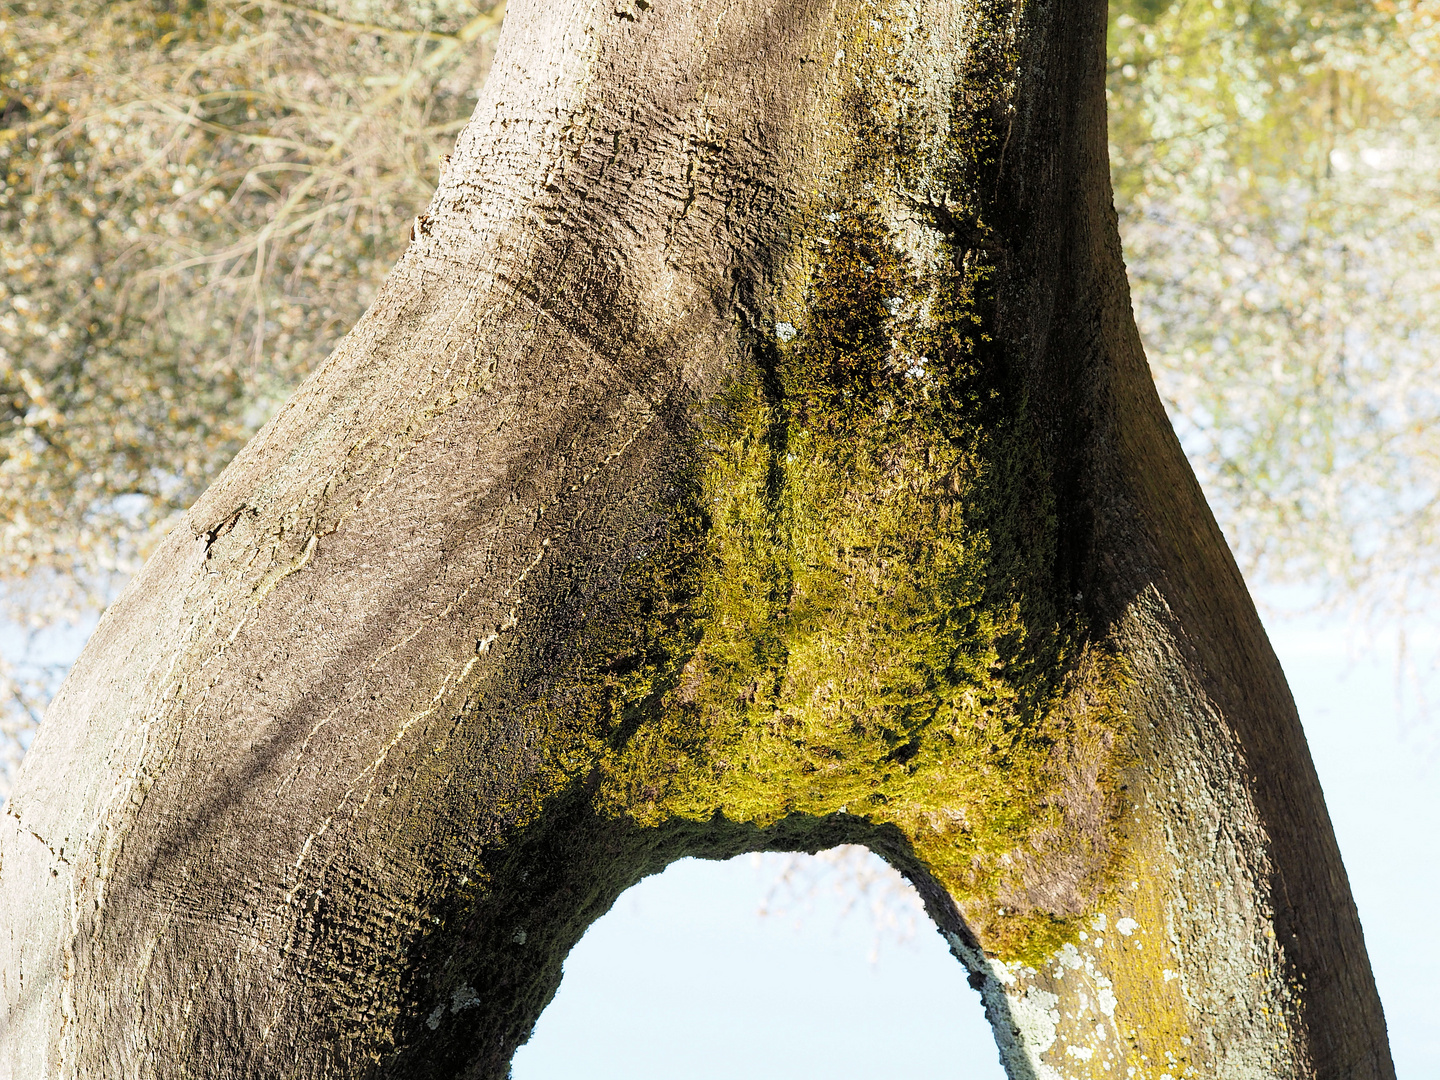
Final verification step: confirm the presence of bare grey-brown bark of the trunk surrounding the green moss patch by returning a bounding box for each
[0,0,1394,1080]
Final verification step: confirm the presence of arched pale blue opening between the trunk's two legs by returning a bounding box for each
[513,847,1005,1080]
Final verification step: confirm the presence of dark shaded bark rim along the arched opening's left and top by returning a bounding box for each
[383,788,1035,1080]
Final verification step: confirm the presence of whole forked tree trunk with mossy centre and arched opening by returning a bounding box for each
[0,0,1394,1080]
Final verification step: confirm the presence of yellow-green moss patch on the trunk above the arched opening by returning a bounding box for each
[466,0,1125,963]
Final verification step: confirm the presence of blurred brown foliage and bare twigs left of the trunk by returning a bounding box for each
[0,0,503,783]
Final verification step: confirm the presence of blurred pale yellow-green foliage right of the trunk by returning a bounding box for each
[1109,0,1440,618]
